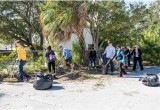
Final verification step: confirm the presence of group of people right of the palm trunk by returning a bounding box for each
[89,41,143,77]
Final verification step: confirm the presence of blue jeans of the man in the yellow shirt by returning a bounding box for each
[18,61,30,80]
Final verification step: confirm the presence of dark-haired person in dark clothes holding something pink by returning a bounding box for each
[45,46,58,79]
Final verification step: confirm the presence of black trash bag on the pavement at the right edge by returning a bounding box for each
[139,73,160,87]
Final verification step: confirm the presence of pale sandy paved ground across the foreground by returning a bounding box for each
[0,67,160,110]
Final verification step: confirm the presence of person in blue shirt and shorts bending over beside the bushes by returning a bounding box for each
[59,46,74,73]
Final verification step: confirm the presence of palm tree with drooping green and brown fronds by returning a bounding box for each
[40,1,88,50]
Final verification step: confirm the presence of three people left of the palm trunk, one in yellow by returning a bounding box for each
[15,40,73,82]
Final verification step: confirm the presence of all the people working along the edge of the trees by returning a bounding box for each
[15,41,143,82]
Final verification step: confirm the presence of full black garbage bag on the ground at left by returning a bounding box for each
[33,73,53,90]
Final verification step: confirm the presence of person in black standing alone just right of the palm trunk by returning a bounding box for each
[89,48,97,67]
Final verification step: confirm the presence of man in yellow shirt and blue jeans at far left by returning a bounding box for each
[15,40,31,82]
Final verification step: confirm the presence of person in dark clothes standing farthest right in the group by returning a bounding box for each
[131,46,143,71]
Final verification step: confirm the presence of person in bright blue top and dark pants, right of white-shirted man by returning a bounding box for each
[116,46,127,77]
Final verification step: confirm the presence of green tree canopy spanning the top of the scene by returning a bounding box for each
[0,1,160,64]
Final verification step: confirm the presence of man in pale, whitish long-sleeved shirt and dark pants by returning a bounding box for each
[103,41,116,74]
